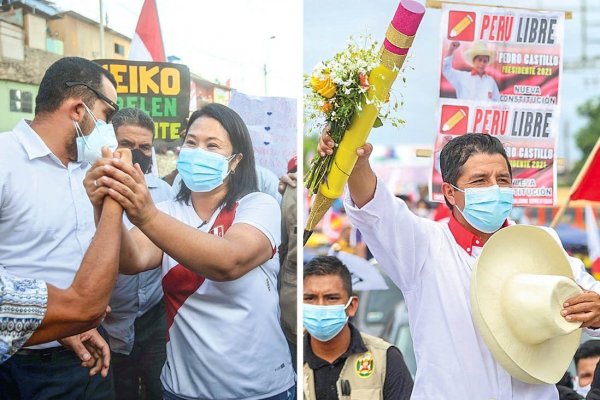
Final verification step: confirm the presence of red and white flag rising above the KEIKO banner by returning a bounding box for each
[129,0,165,62]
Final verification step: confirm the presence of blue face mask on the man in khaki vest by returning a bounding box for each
[303,297,352,342]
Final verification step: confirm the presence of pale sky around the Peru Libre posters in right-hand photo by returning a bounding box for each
[303,0,600,166]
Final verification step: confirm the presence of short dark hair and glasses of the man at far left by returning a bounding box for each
[35,57,117,115]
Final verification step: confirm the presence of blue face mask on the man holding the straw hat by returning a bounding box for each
[452,185,513,233]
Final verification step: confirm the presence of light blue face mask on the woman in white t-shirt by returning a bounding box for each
[177,147,235,192]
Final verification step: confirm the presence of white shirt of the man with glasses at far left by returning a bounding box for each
[0,120,96,348]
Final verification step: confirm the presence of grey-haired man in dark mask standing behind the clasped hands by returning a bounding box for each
[102,108,171,400]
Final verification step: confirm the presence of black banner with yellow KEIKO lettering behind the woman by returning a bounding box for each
[94,60,190,147]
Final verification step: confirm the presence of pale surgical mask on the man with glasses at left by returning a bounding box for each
[73,104,118,164]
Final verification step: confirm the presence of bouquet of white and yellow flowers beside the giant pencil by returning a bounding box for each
[304,37,404,193]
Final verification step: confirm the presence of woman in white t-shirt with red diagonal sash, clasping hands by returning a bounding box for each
[86,104,295,400]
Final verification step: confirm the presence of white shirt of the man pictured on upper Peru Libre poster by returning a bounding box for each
[442,56,500,101]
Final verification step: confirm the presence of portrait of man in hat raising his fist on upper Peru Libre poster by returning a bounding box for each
[442,42,500,101]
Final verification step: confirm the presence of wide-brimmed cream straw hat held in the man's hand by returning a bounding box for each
[471,225,583,383]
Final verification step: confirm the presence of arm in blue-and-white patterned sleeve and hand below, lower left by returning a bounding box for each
[0,165,123,368]
